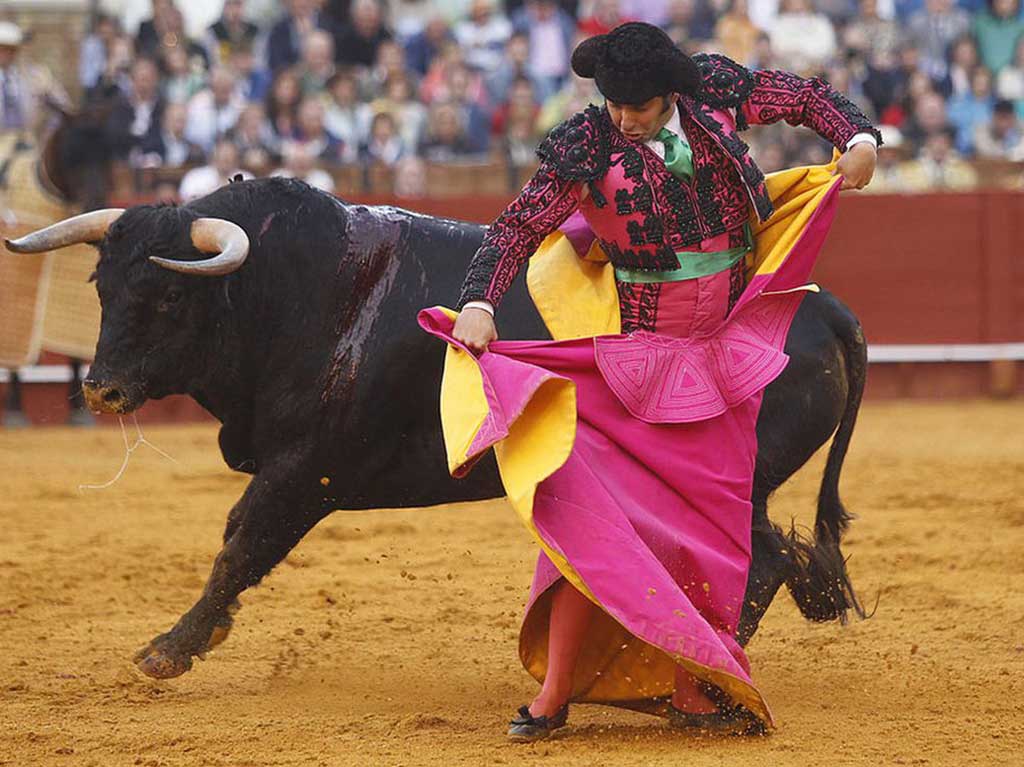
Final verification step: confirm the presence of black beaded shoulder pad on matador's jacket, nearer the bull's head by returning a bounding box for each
[537,104,611,181]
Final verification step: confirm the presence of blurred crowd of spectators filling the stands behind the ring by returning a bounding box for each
[0,0,1024,199]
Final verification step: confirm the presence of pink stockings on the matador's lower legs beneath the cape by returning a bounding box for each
[529,580,717,717]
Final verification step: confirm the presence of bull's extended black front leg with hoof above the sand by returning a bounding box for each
[134,475,327,679]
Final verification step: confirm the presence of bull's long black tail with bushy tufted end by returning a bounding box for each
[785,314,867,623]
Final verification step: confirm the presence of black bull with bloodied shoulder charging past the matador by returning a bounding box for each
[12,179,865,677]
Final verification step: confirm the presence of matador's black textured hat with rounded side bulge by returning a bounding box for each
[572,22,700,104]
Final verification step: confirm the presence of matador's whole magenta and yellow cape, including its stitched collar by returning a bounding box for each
[420,159,841,723]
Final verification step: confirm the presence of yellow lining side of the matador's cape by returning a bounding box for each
[441,160,841,723]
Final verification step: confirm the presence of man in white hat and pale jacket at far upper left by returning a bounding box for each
[0,22,71,133]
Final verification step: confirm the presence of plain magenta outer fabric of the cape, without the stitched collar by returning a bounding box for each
[420,310,761,712]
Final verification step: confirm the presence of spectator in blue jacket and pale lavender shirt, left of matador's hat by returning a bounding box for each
[512,0,575,100]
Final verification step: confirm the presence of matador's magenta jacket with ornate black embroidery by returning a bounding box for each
[459,54,881,332]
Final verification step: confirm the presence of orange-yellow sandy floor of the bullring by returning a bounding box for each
[0,401,1024,767]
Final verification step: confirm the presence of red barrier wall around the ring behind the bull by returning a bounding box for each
[0,191,1024,423]
